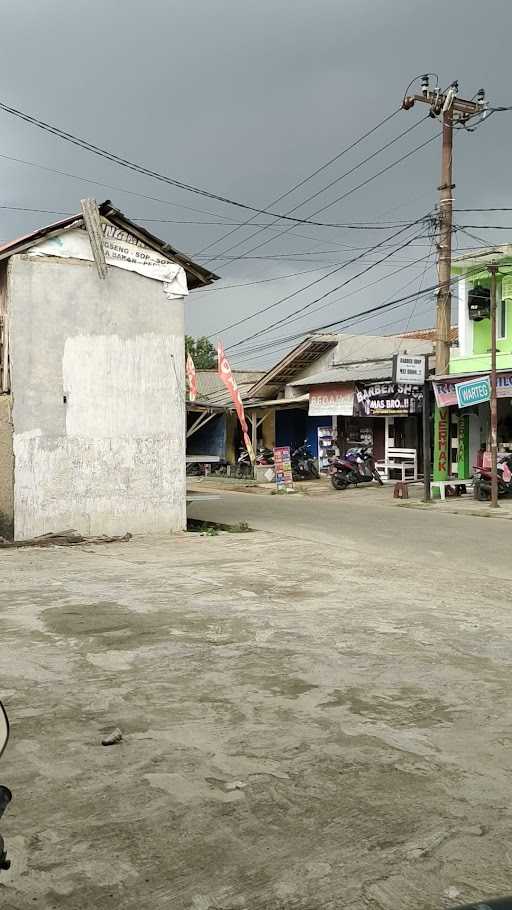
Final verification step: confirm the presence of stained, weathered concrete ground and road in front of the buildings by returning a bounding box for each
[0,494,512,910]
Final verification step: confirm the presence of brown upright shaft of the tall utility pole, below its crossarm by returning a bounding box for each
[436,107,453,376]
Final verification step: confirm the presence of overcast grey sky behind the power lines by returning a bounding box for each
[0,0,512,367]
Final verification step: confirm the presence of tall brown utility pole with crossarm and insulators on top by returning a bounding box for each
[402,74,487,375]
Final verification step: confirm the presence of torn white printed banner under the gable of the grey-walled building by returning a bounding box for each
[29,218,188,300]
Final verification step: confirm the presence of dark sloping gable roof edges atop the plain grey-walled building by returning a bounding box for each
[0,199,219,290]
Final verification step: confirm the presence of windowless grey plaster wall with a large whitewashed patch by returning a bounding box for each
[7,255,186,539]
